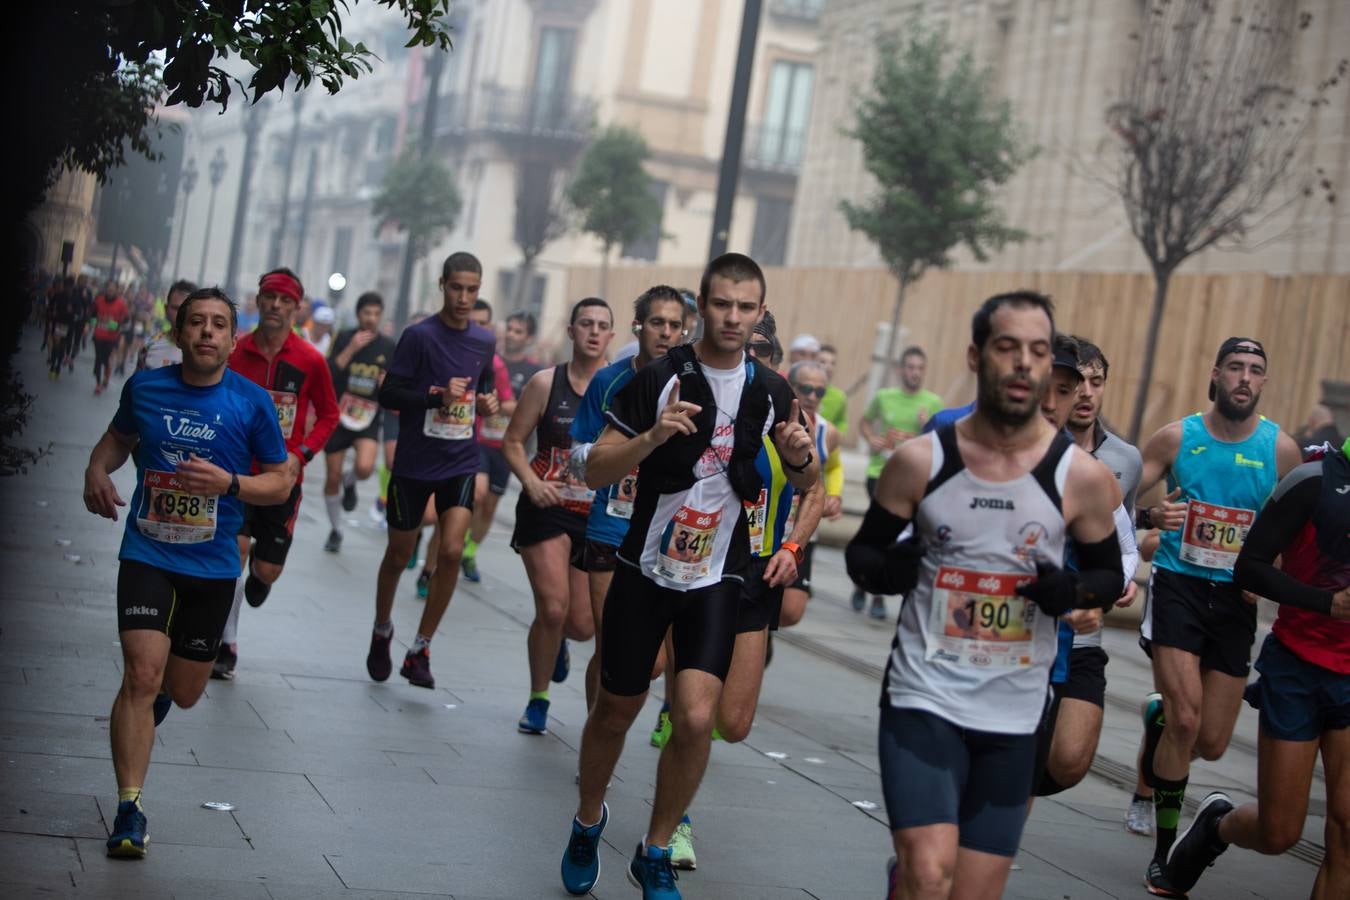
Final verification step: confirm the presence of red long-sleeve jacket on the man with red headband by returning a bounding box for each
[230,332,338,483]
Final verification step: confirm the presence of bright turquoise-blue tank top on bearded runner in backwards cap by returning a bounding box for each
[1153,413,1280,582]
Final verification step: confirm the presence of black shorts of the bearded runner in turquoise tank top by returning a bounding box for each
[1149,565,1257,679]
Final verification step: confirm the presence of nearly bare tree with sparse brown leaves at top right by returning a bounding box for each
[1106,0,1350,443]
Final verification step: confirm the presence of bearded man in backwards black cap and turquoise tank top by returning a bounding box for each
[1137,337,1300,897]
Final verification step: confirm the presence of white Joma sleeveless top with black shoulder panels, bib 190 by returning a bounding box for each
[882,425,1073,734]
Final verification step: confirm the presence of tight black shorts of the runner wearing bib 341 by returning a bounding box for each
[599,560,741,696]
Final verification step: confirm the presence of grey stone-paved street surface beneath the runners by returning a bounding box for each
[0,335,1324,900]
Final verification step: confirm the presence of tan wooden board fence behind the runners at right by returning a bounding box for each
[567,266,1350,445]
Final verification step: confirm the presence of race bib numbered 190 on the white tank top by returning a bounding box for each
[925,565,1037,668]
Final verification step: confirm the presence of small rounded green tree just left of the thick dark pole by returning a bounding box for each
[567,125,662,296]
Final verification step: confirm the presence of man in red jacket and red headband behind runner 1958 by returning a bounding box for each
[211,269,338,679]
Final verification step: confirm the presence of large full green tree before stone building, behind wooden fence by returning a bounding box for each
[840,22,1035,369]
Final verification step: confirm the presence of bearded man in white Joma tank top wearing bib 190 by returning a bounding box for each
[846,291,1122,900]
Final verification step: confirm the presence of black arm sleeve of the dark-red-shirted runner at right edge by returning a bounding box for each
[1233,463,1332,615]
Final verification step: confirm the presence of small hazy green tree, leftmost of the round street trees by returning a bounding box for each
[370,148,463,310]
